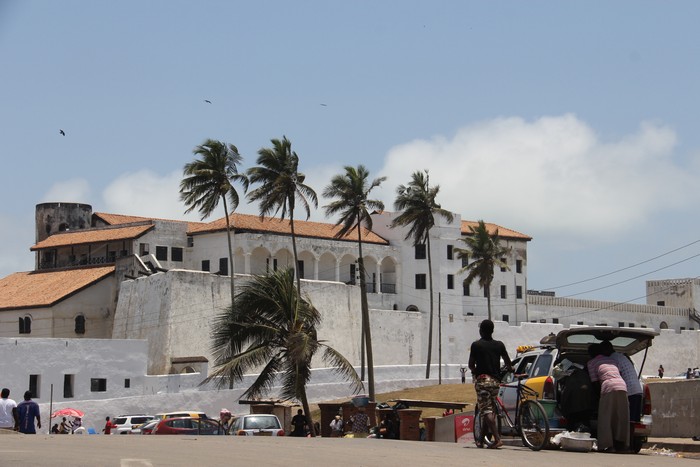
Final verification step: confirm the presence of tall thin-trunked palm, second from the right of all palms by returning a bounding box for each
[391,171,454,379]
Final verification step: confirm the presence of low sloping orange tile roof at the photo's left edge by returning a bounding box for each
[0,266,114,310]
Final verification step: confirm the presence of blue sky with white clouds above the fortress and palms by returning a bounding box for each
[0,0,700,303]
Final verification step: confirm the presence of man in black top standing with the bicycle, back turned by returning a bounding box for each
[469,319,513,449]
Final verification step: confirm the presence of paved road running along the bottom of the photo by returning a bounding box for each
[0,435,700,467]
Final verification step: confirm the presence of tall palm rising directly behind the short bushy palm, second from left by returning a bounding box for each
[248,136,318,294]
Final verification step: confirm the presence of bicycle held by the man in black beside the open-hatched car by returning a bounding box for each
[474,374,549,451]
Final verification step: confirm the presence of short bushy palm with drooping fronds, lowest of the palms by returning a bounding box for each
[204,268,363,436]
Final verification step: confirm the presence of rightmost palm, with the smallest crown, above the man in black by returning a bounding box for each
[455,220,511,319]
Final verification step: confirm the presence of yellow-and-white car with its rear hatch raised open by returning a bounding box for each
[499,327,659,452]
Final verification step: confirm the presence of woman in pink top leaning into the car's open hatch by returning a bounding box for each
[587,344,630,452]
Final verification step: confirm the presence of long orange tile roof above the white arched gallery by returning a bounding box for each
[189,213,389,245]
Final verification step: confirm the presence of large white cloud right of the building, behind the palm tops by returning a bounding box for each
[374,114,699,243]
